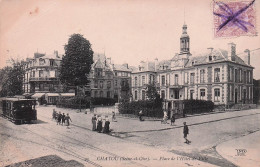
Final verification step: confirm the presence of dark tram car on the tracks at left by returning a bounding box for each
[0,98,37,124]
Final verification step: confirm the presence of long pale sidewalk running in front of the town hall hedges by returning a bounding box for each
[39,106,260,133]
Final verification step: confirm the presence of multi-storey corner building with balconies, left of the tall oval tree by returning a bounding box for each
[23,52,61,93]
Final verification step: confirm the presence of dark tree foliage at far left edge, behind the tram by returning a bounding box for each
[0,62,25,97]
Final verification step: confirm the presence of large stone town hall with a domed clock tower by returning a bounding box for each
[131,25,253,109]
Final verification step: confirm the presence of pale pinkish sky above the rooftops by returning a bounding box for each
[0,0,260,79]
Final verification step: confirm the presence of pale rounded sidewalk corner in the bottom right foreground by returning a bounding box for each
[216,131,260,167]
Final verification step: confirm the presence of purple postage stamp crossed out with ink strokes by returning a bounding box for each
[213,0,257,38]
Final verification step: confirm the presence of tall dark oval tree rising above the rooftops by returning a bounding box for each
[60,34,94,87]
